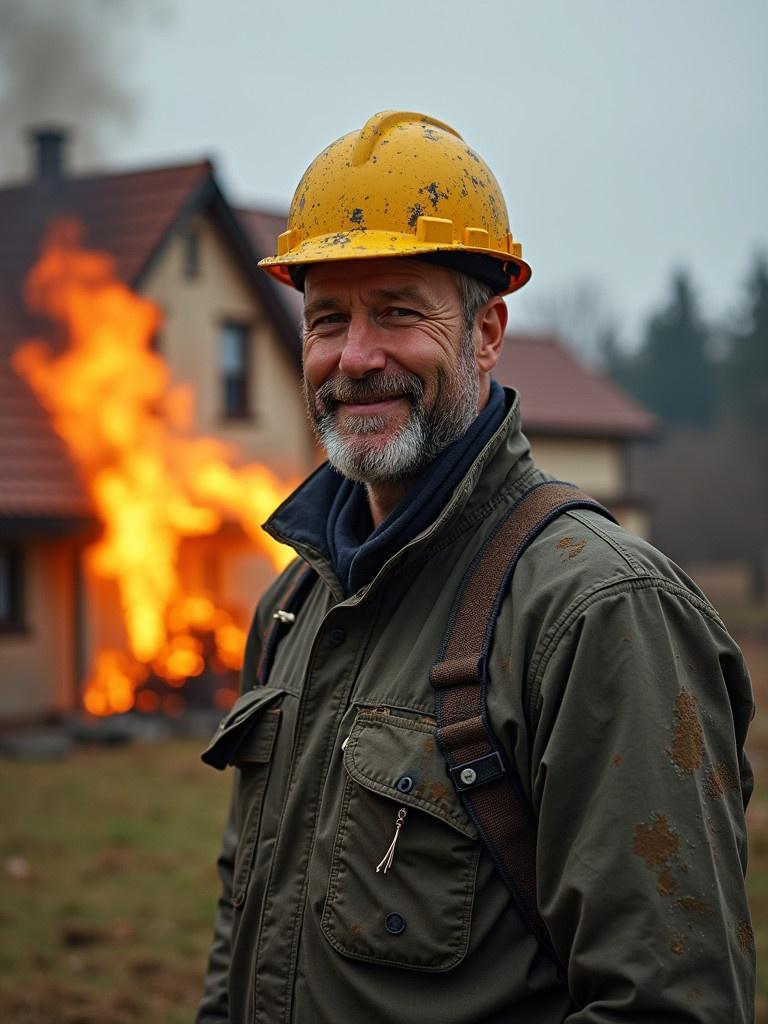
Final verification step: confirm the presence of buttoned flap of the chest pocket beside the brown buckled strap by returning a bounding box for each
[344,710,477,839]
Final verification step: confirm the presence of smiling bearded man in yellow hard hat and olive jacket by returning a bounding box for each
[198,112,754,1024]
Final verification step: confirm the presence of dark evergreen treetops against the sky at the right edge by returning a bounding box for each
[601,254,768,439]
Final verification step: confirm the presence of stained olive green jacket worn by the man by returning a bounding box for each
[198,391,754,1024]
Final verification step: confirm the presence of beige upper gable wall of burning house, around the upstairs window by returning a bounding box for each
[141,217,316,477]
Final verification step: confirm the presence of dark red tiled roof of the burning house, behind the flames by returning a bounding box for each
[0,160,300,518]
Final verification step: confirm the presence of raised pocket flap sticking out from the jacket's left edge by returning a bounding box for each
[200,686,286,770]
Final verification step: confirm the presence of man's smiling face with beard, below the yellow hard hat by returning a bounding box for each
[304,253,480,484]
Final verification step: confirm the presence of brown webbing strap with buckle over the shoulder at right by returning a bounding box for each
[430,481,615,971]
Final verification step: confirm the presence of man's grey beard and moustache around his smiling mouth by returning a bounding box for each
[304,333,480,484]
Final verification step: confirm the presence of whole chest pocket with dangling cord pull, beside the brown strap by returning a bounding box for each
[322,711,480,971]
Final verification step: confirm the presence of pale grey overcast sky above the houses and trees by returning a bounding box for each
[0,0,768,348]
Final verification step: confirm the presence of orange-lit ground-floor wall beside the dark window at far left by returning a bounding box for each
[0,541,75,721]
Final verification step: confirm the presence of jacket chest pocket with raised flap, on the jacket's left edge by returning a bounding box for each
[202,686,285,906]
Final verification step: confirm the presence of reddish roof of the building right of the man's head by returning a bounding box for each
[494,334,658,438]
